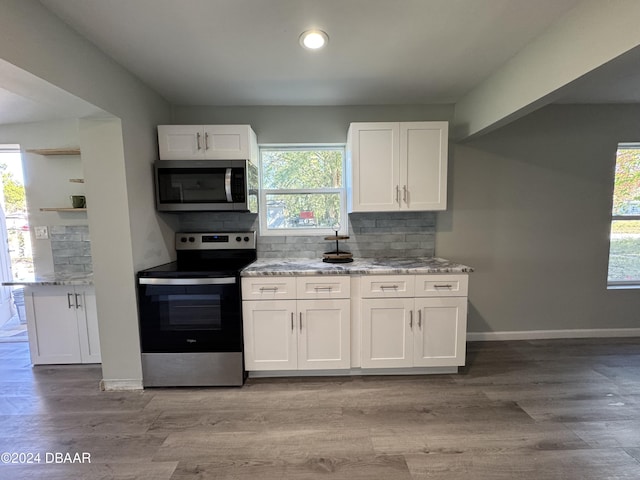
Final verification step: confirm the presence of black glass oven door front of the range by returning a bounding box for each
[139,284,242,352]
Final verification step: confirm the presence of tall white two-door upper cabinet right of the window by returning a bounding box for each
[347,122,449,212]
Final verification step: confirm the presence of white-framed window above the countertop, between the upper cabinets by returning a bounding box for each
[260,145,347,235]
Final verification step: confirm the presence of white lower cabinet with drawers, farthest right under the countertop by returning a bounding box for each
[361,275,467,368]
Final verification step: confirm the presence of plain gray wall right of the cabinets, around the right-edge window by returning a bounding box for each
[436,105,640,332]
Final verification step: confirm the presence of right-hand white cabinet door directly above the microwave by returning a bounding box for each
[204,125,255,160]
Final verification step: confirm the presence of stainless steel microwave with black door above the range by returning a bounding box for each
[155,160,258,213]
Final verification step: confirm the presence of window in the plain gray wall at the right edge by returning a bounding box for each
[608,143,640,286]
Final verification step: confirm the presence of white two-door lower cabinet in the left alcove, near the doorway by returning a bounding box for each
[25,286,101,365]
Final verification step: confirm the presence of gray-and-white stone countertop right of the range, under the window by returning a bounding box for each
[241,257,473,277]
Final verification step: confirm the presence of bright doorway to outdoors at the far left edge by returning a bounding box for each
[0,144,33,342]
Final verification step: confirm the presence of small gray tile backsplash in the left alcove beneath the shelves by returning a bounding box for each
[49,225,93,273]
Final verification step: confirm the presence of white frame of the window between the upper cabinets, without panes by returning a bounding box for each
[258,143,349,237]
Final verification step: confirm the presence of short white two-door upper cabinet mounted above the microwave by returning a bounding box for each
[158,125,258,163]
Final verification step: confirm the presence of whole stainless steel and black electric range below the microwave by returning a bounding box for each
[138,232,256,387]
